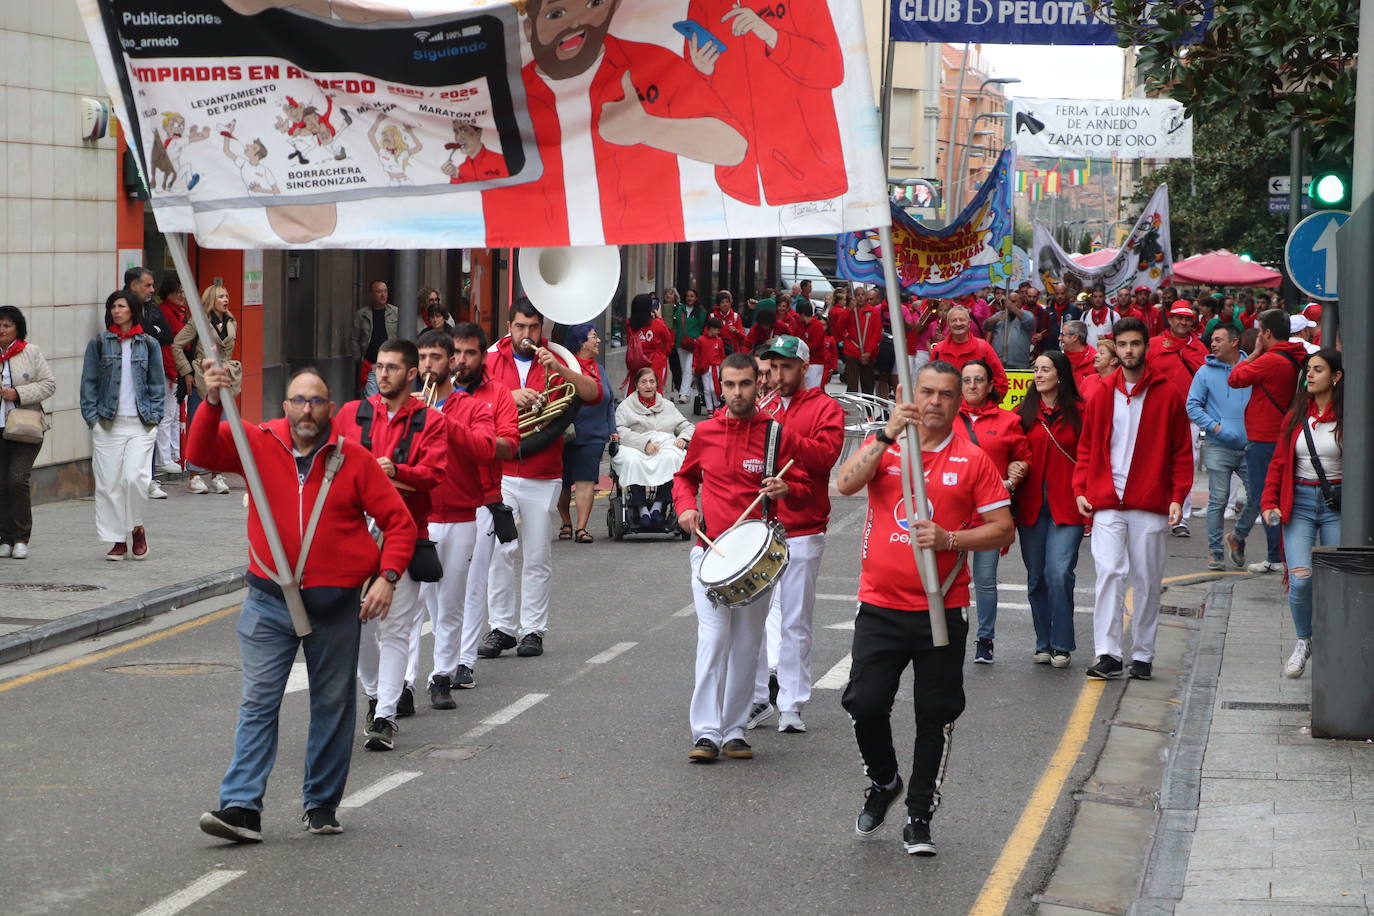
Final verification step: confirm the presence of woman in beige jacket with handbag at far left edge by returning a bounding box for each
[0,305,58,560]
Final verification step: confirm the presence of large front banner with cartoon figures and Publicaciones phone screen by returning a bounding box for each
[80,0,888,249]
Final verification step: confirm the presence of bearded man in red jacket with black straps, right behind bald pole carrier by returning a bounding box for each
[335,338,448,751]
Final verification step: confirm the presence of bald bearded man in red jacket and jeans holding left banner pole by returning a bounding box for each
[185,367,415,843]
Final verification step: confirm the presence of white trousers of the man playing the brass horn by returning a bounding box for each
[486,477,563,637]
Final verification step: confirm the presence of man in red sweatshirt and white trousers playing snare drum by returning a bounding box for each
[673,353,815,764]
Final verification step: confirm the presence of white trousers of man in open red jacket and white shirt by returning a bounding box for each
[1092,509,1169,662]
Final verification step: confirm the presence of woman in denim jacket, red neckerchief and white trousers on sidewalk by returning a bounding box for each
[81,290,166,560]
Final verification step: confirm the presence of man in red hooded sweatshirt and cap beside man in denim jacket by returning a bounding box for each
[1226,309,1307,573]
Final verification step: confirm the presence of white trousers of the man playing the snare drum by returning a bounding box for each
[690,547,768,744]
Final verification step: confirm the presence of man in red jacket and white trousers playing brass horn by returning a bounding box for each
[477,297,602,658]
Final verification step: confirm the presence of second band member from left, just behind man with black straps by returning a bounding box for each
[407,330,496,709]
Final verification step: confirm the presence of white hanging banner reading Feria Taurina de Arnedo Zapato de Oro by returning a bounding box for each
[1011,99,1193,159]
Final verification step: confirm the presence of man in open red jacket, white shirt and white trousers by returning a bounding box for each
[1073,319,1193,681]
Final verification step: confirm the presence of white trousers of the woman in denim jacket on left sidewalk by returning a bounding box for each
[91,416,155,544]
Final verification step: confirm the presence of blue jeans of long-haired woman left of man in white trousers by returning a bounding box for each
[1017,503,1083,652]
